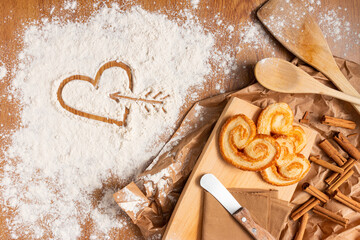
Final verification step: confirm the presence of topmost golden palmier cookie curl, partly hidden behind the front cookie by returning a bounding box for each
[257,103,294,135]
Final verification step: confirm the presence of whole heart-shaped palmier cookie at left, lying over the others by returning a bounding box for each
[219,114,280,171]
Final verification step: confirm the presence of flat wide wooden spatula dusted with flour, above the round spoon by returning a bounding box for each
[257,0,360,113]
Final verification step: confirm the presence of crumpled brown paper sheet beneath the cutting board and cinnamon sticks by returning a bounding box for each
[115,58,360,240]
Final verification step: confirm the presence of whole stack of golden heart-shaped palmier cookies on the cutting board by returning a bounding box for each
[219,103,310,186]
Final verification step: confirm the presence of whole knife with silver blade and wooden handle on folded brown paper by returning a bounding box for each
[200,173,275,240]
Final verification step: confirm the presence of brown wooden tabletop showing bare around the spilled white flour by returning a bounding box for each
[0,0,360,239]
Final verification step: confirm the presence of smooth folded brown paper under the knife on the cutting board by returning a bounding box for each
[202,189,293,240]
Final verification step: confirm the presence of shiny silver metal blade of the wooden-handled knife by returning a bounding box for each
[200,173,242,215]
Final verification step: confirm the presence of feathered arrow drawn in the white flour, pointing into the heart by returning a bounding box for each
[109,90,170,113]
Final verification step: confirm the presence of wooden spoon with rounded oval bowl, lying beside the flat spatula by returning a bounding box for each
[255,58,360,104]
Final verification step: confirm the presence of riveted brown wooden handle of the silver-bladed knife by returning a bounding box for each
[233,208,276,240]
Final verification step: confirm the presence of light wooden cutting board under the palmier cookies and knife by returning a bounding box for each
[163,98,317,240]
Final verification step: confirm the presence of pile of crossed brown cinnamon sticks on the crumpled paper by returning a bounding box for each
[291,132,360,240]
